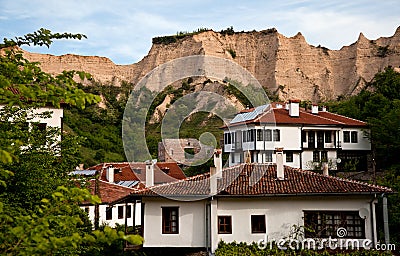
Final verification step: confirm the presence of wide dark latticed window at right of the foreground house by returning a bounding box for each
[304,211,365,238]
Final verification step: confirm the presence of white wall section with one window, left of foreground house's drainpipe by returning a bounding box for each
[143,199,205,247]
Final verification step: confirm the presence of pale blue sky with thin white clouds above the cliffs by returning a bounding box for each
[0,0,400,65]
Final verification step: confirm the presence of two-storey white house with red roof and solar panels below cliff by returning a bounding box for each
[223,100,371,171]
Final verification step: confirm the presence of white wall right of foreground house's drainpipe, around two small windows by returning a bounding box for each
[217,197,372,247]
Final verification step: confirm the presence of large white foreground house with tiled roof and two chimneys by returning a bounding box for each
[114,150,393,253]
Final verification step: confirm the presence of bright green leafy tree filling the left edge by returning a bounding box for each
[0,29,142,255]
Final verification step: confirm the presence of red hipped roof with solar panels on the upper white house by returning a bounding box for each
[223,103,367,128]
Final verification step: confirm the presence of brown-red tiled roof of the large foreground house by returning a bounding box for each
[133,164,393,196]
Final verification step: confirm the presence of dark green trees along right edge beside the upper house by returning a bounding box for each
[328,67,400,243]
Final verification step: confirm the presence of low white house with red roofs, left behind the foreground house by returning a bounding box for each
[75,162,186,227]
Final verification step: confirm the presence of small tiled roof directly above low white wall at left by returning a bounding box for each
[83,179,136,204]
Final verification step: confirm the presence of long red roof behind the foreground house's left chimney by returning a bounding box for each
[88,162,186,184]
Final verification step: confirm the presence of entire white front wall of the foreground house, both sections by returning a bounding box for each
[144,196,378,249]
